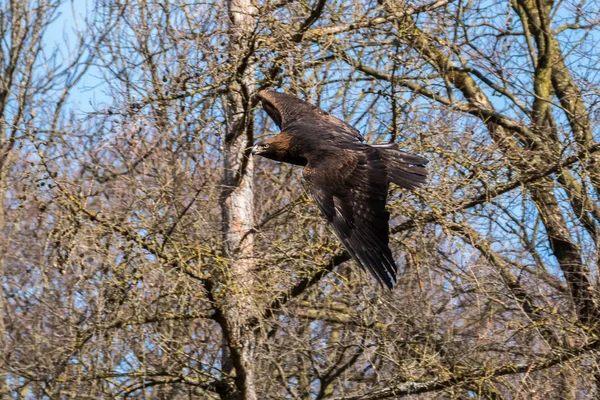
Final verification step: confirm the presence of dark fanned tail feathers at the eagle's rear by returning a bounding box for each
[373,143,429,190]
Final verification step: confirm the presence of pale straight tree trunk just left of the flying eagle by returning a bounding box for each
[221,0,257,400]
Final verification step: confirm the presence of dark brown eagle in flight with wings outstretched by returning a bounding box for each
[252,89,428,289]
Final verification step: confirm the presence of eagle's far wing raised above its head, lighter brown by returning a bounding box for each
[258,89,364,142]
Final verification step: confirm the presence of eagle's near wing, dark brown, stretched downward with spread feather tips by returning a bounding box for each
[303,144,397,289]
